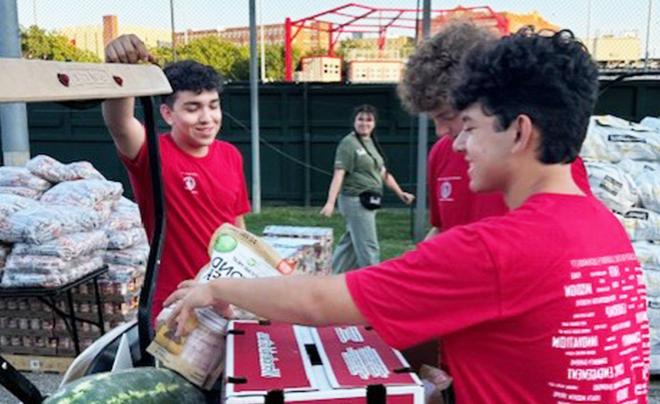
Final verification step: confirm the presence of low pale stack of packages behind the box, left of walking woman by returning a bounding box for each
[263,225,333,275]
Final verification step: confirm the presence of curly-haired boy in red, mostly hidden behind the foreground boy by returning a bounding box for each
[398,21,591,237]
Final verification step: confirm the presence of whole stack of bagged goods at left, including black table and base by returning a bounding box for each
[0,155,149,357]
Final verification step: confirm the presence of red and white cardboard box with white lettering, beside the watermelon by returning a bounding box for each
[224,321,424,404]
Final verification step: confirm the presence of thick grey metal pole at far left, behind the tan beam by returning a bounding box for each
[0,1,30,166]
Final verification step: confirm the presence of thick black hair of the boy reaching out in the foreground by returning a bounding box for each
[452,30,598,164]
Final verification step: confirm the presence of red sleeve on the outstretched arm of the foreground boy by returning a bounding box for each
[346,226,501,348]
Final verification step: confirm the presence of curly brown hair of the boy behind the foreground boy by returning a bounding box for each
[397,20,495,113]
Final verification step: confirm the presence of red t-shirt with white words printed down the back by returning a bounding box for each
[346,194,650,403]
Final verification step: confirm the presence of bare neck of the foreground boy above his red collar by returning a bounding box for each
[504,161,584,210]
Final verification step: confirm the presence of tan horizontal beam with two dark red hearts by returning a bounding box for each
[0,58,172,103]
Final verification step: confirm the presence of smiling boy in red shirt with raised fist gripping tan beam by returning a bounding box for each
[103,35,250,322]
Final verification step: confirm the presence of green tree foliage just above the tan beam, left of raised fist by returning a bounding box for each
[21,25,101,62]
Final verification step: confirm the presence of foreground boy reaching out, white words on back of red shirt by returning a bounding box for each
[166,31,649,403]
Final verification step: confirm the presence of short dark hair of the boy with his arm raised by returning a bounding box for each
[161,60,222,107]
